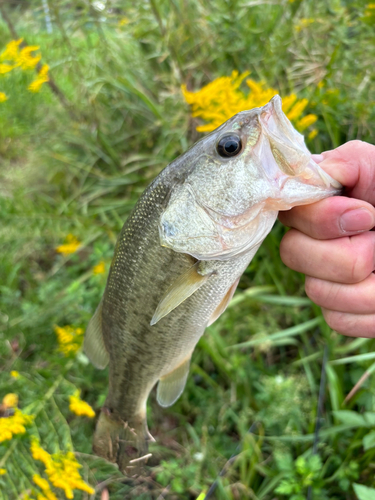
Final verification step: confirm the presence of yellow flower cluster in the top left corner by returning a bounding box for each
[0,38,49,102]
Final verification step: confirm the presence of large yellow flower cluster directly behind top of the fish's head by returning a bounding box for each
[182,71,318,139]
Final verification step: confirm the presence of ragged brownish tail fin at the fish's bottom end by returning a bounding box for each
[93,407,154,476]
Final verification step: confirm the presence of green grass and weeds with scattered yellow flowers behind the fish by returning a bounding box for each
[0,0,375,500]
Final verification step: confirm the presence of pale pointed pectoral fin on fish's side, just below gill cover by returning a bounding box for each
[150,261,212,325]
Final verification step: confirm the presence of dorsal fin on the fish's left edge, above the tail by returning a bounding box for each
[83,299,109,370]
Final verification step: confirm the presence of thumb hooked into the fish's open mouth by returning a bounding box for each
[315,141,375,205]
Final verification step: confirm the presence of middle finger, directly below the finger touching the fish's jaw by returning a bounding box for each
[280,229,375,283]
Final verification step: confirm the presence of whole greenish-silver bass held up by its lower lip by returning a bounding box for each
[84,95,341,476]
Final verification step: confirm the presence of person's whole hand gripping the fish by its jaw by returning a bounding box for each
[279,141,375,337]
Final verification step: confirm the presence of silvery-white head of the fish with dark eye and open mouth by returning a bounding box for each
[159,95,341,260]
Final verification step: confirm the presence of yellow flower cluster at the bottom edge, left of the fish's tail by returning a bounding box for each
[30,440,95,500]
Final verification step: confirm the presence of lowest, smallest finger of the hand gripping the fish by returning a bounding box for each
[322,308,375,338]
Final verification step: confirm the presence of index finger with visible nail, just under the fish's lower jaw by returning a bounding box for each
[279,196,375,240]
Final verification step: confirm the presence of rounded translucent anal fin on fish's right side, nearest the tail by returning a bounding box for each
[156,355,191,407]
